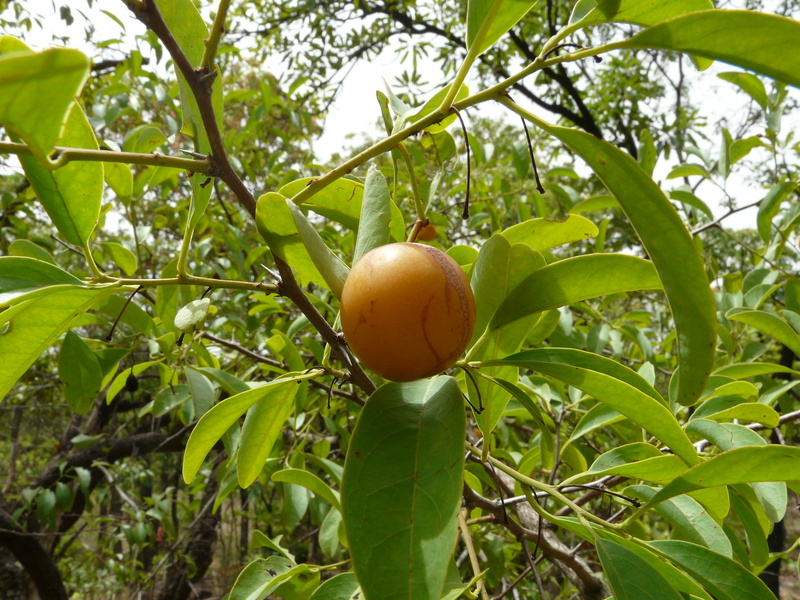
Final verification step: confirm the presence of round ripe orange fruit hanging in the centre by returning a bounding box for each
[341,242,475,381]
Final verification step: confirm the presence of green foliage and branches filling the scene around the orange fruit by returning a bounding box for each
[0,0,800,600]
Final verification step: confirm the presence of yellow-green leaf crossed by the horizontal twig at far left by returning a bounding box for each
[19,103,103,247]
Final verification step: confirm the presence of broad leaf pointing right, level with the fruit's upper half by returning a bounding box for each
[490,254,661,328]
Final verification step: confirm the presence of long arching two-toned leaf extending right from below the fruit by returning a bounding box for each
[481,348,698,465]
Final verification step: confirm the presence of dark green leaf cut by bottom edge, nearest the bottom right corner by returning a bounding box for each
[649,540,775,600]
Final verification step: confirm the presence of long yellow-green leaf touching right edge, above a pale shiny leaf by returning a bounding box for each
[648,446,800,505]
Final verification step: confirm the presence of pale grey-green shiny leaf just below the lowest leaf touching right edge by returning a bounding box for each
[625,485,733,558]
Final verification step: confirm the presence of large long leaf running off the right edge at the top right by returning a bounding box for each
[622,10,800,87]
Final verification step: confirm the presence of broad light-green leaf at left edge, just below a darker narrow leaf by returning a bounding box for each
[0,286,114,398]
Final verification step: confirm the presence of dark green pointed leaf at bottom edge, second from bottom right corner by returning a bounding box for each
[597,539,683,600]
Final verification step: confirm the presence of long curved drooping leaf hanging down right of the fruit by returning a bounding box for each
[535,119,716,406]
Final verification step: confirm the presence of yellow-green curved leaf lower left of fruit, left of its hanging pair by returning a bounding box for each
[183,379,297,483]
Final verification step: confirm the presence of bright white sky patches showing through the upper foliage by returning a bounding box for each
[7,0,800,229]
